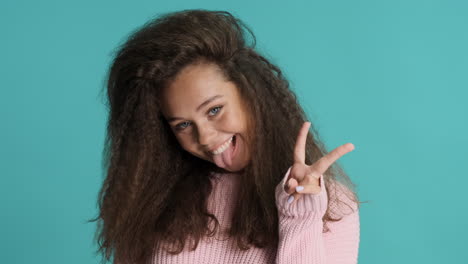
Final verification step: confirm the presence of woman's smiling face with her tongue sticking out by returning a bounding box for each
[161,64,250,172]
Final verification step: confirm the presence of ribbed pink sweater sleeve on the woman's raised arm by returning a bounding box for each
[275,168,360,264]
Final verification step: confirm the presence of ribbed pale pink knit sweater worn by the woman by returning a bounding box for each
[153,168,360,264]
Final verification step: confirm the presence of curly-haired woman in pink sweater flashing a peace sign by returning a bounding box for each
[93,10,359,264]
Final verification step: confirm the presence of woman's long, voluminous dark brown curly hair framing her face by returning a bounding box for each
[90,9,359,263]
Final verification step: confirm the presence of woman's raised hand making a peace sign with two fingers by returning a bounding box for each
[284,122,354,203]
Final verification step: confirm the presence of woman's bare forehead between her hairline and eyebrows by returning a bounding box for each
[162,63,238,113]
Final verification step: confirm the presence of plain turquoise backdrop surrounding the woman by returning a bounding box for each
[0,0,468,264]
